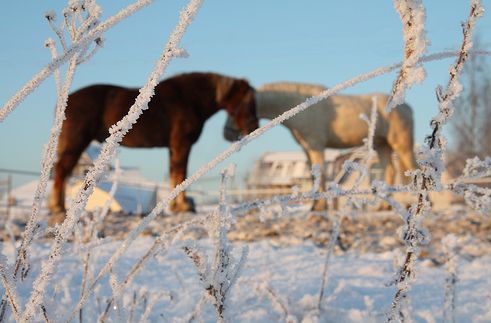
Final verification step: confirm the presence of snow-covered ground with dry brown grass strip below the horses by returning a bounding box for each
[2,204,491,322]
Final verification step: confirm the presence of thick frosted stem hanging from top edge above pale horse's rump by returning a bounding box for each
[386,0,427,112]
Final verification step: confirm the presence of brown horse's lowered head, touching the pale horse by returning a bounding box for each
[217,78,259,141]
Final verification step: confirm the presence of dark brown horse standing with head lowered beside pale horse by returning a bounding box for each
[48,73,258,223]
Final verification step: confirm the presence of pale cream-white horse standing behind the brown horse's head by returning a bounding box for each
[224,82,417,210]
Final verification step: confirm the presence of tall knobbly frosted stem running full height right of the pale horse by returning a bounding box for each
[388,0,483,321]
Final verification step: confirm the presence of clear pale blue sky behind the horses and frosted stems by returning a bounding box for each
[0,0,491,188]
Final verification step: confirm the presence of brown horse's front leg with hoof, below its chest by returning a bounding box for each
[169,139,196,213]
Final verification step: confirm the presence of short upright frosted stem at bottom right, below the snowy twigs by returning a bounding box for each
[442,234,458,323]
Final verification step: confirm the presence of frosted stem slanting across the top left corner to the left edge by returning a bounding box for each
[0,0,153,122]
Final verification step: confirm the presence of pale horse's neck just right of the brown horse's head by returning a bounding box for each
[256,91,307,119]
